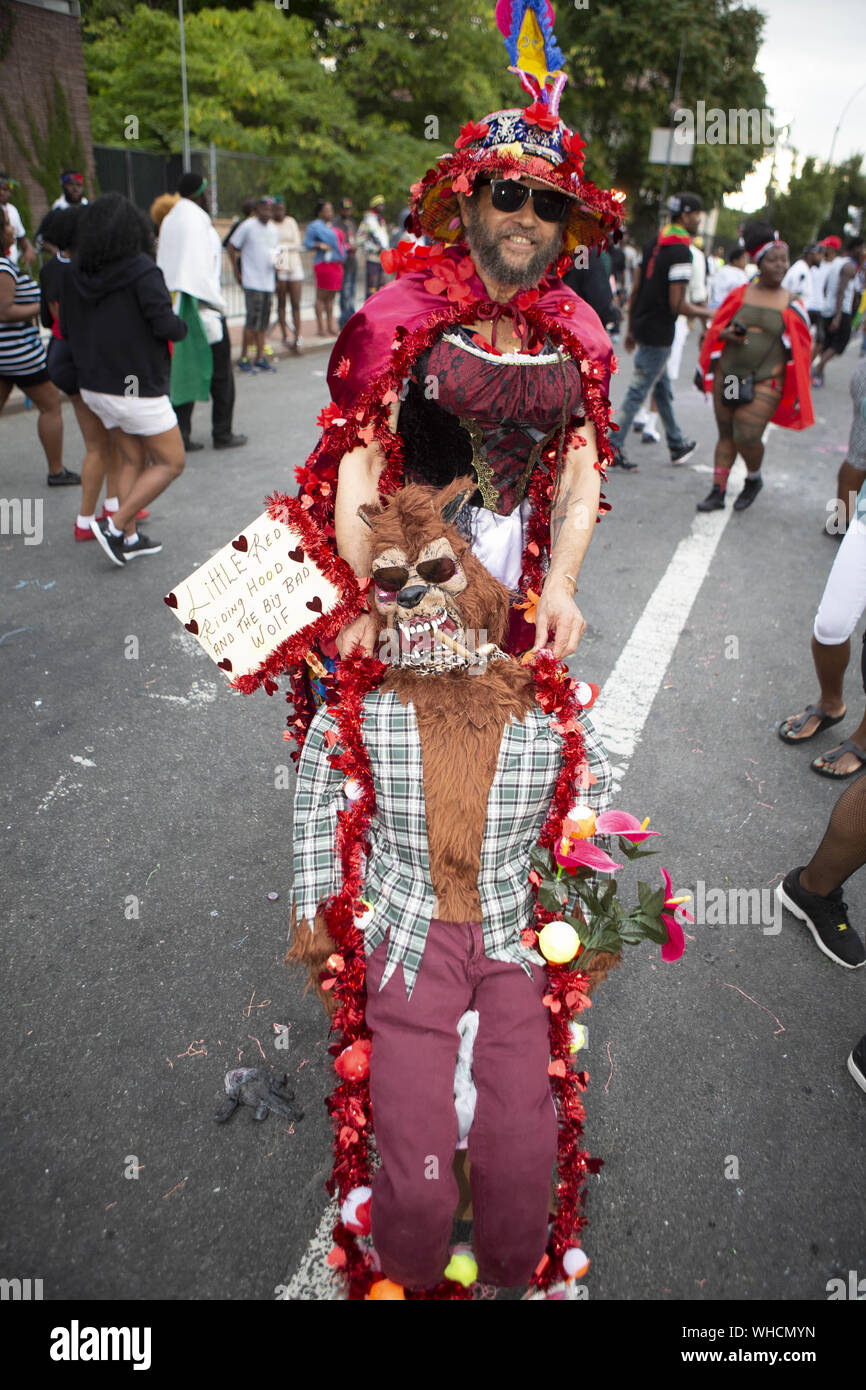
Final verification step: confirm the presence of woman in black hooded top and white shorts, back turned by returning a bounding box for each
[60,193,186,566]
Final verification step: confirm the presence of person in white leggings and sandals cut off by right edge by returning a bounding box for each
[778,363,866,778]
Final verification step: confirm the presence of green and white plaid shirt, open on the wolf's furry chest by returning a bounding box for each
[293,691,612,997]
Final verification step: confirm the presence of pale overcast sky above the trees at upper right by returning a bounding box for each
[726,0,866,209]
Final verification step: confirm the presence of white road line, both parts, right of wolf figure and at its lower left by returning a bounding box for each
[285,461,745,1302]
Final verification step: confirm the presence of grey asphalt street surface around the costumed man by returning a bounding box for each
[0,328,866,1302]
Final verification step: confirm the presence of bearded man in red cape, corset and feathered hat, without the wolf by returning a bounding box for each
[291,0,623,738]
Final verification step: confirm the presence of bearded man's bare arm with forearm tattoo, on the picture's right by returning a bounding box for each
[534,421,602,660]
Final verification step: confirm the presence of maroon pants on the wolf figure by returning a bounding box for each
[367,917,556,1289]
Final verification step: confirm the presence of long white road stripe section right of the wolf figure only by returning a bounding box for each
[592,463,745,791]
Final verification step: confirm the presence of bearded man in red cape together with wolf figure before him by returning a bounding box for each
[289,0,681,1300]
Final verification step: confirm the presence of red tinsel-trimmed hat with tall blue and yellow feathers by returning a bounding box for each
[411,0,626,254]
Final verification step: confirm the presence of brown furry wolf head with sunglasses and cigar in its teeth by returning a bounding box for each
[359,477,509,669]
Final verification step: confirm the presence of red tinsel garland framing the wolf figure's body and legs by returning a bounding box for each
[312,653,601,1300]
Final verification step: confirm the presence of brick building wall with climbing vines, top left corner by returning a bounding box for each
[0,0,95,235]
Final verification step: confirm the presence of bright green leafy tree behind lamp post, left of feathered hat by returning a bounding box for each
[85,4,447,206]
